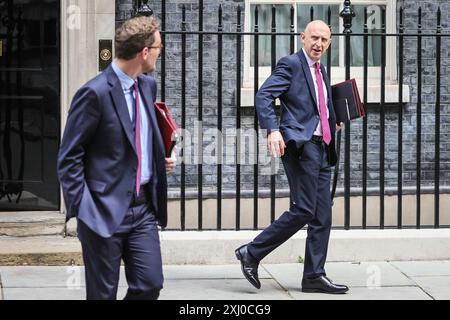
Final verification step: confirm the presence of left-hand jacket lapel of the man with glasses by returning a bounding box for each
[105,66,136,152]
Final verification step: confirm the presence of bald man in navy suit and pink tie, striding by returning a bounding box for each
[235,20,348,293]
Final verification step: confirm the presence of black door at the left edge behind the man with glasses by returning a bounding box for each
[0,0,60,211]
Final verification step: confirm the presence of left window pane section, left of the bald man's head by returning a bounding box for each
[250,4,291,67]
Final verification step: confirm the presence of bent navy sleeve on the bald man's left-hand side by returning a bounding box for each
[255,58,293,132]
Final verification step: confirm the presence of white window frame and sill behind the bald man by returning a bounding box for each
[243,0,397,88]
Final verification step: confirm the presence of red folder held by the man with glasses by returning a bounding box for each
[155,102,178,158]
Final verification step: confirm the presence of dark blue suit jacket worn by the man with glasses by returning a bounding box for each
[58,66,167,237]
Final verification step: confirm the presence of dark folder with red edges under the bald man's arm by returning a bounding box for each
[331,79,366,124]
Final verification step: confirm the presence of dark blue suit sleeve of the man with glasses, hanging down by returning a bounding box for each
[57,87,100,217]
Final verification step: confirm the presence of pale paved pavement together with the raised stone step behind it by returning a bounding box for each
[0,229,450,300]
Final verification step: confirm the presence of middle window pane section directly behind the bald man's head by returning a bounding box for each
[297,4,340,66]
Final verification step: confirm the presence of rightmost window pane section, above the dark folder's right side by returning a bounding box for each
[351,5,386,67]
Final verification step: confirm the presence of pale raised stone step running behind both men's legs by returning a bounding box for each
[0,229,450,266]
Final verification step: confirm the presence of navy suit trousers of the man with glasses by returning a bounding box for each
[78,204,163,300]
